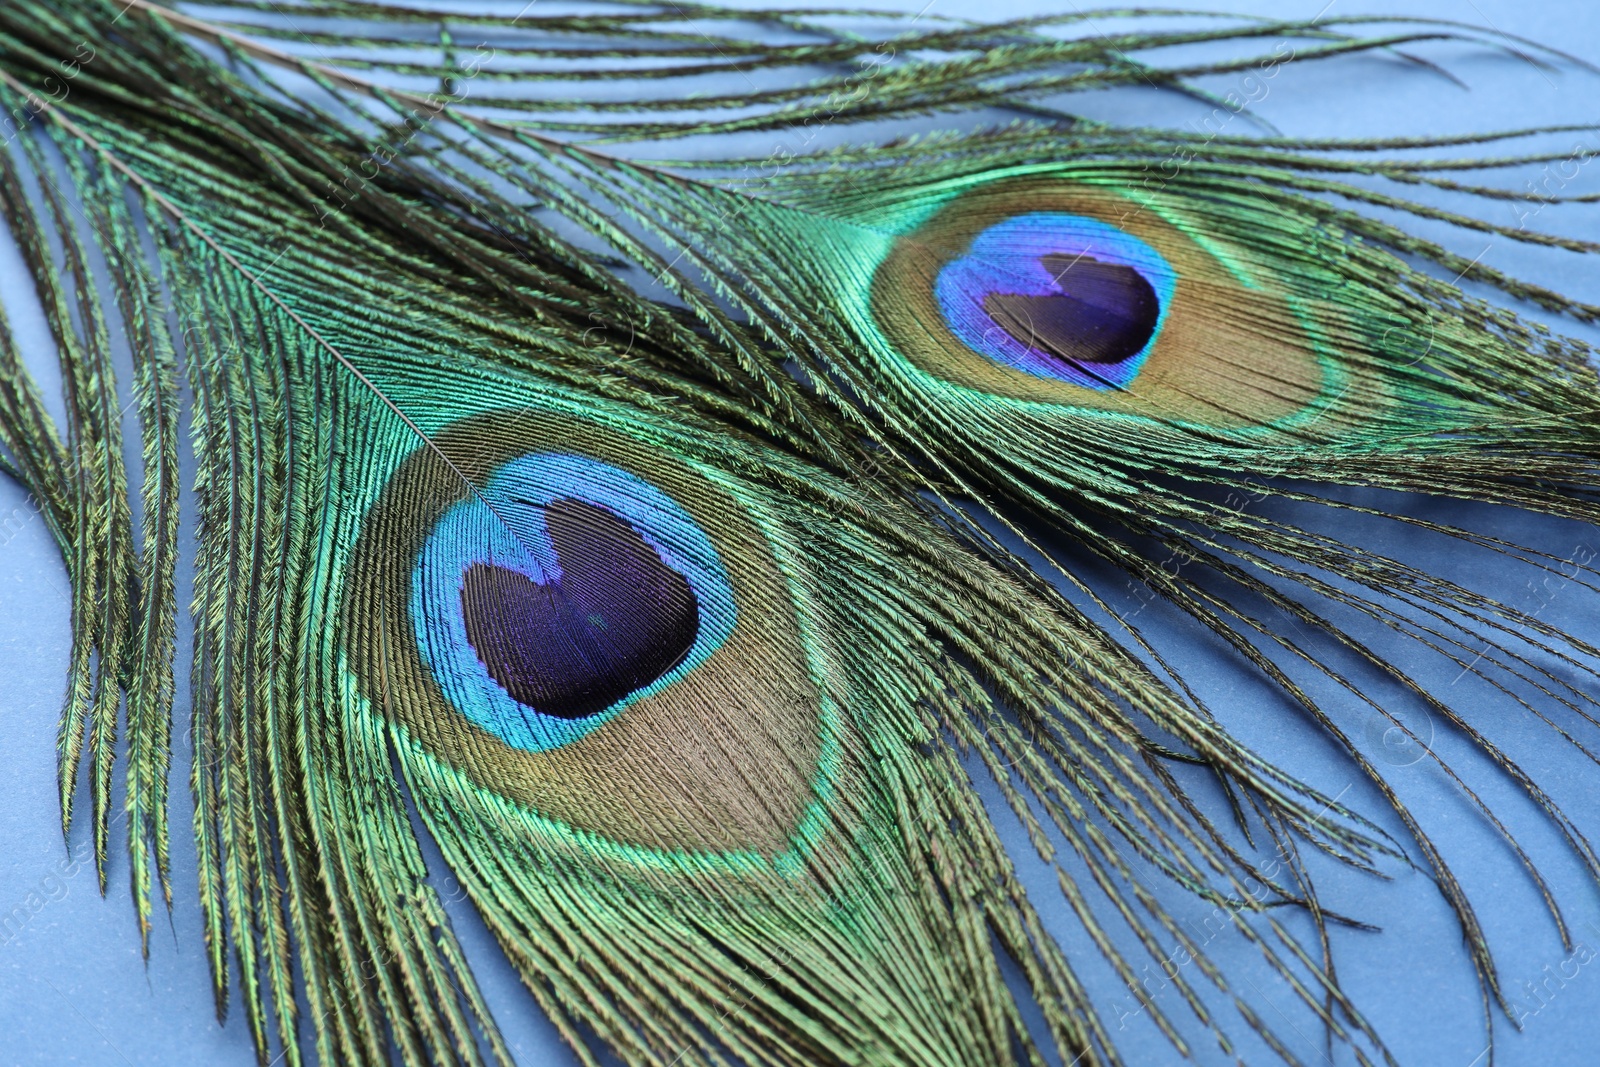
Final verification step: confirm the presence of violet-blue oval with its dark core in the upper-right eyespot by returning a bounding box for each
[934,211,1178,389]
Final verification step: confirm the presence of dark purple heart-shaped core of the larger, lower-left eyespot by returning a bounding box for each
[461,499,699,718]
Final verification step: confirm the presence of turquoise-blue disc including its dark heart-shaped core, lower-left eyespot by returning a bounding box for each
[410,453,738,752]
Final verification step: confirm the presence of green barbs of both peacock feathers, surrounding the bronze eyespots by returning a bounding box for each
[0,0,1600,1067]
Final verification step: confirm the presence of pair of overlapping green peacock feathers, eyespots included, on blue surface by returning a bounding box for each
[0,0,1600,1067]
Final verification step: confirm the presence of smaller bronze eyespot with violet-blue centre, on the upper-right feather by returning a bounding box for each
[869,178,1328,427]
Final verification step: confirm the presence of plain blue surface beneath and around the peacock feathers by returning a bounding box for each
[0,0,1600,1067]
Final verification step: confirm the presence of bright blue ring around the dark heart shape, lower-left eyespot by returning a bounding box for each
[410,453,738,752]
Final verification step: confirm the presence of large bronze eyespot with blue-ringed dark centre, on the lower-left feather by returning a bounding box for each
[339,410,822,854]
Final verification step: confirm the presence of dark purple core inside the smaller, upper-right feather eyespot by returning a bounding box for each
[984,256,1162,371]
